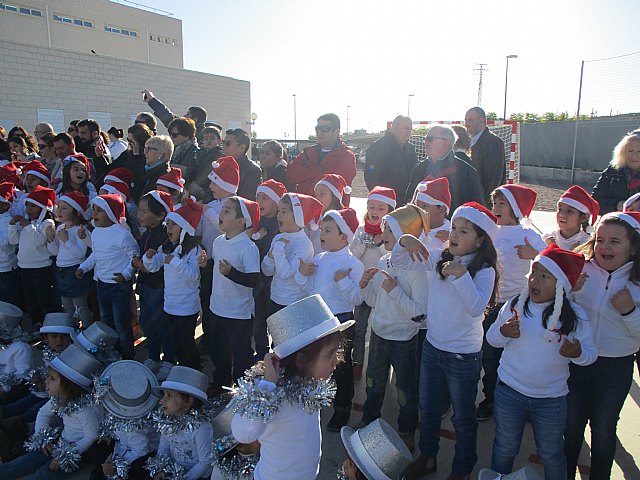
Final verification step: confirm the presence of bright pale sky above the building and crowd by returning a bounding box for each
[142,0,640,139]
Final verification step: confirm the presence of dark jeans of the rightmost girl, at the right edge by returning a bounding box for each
[565,355,633,480]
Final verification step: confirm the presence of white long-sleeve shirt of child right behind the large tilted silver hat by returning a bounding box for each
[295,246,364,315]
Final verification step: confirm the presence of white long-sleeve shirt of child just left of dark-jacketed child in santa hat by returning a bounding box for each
[80,224,140,283]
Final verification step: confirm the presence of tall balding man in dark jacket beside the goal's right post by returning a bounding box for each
[464,107,507,205]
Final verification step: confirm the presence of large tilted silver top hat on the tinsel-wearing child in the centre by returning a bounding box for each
[267,295,355,358]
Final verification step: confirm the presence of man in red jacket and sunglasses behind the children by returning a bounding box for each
[287,113,356,196]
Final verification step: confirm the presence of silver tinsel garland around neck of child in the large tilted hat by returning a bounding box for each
[230,362,336,423]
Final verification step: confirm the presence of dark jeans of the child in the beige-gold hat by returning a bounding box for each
[356,332,418,433]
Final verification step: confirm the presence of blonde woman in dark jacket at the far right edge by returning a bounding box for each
[592,130,640,215]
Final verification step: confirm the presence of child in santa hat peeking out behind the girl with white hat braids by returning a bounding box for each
[542,185,600,250]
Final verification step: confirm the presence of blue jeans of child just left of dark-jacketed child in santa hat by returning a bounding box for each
[97,280,135,359]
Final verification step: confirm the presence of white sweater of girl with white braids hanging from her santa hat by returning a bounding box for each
[487,301,598,398]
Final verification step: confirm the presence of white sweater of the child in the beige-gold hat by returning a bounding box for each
[362,253,429,341]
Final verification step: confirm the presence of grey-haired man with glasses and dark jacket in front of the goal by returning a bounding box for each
[405,125,484,215]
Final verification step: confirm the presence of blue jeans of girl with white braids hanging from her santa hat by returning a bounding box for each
[491,380,567,480]
